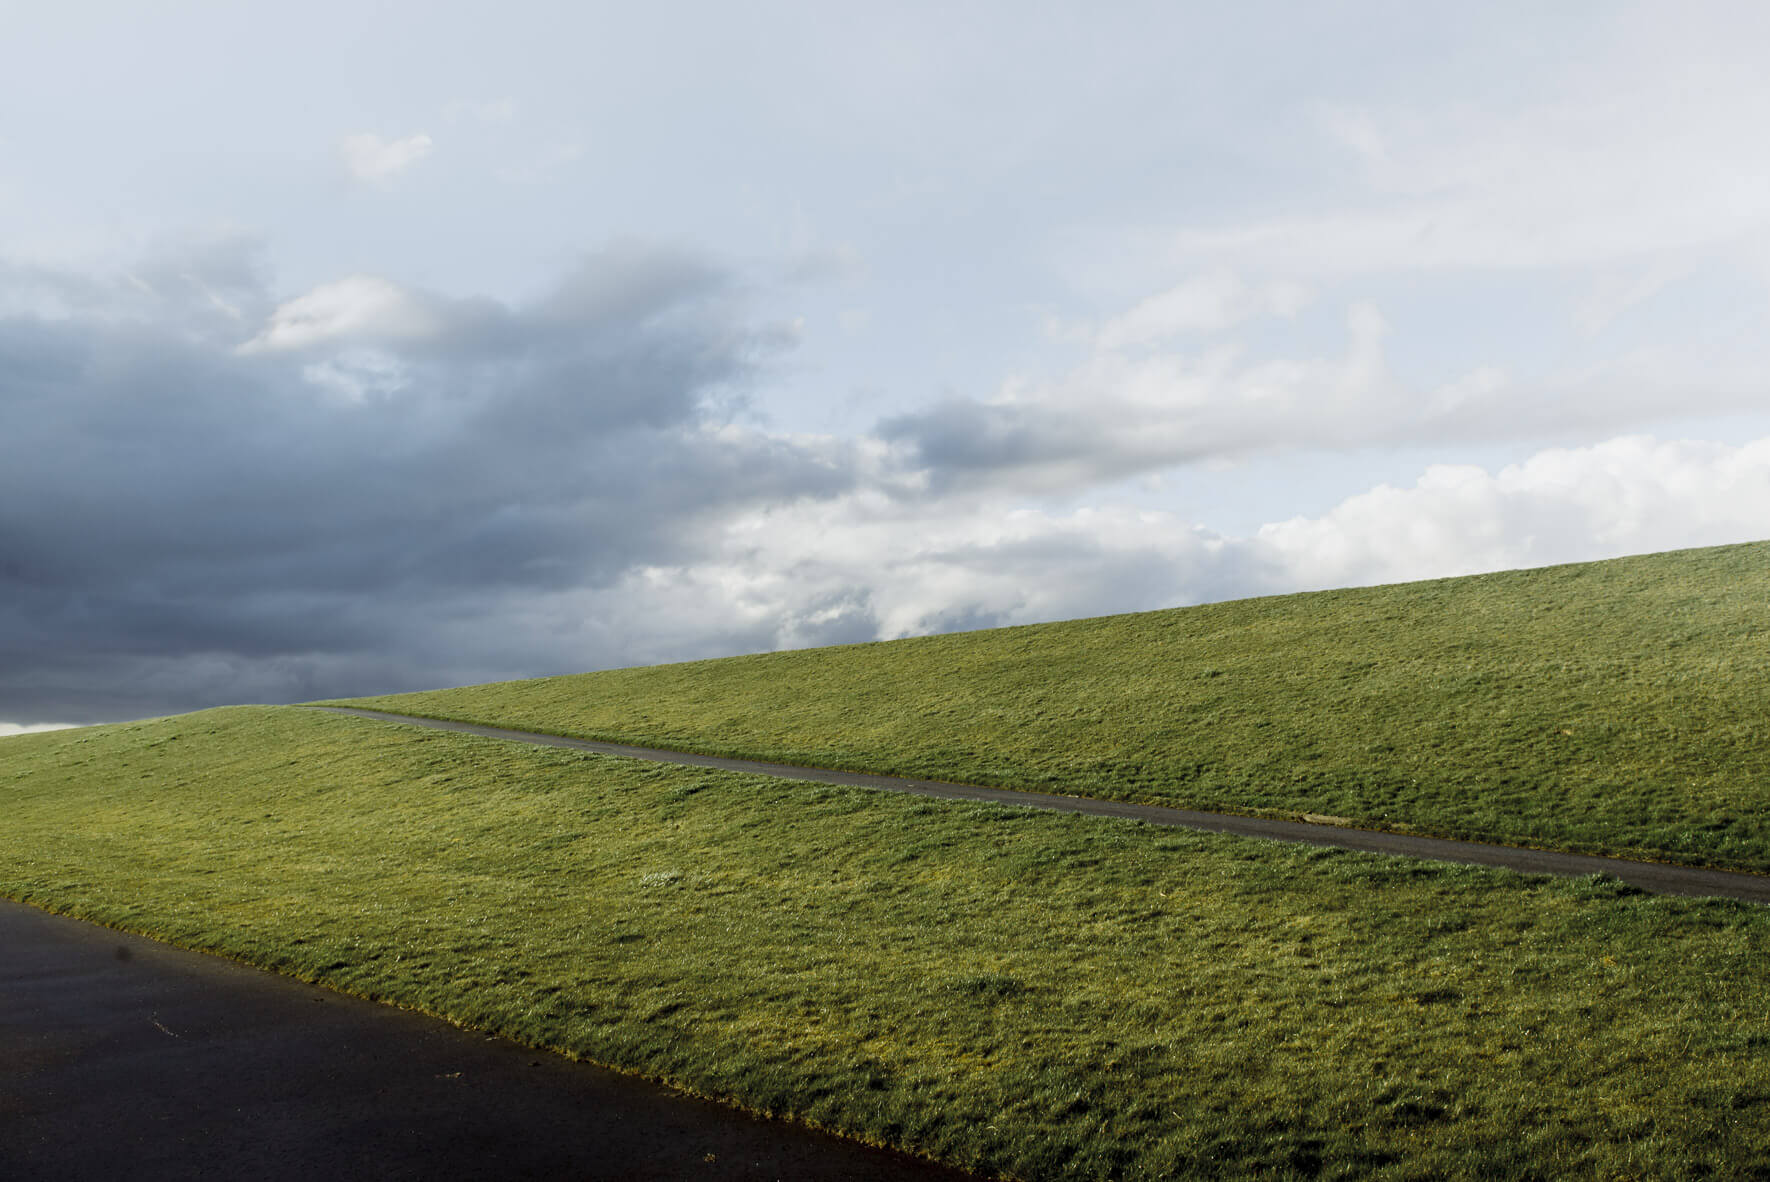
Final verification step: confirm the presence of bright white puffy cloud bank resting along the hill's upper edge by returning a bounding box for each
[594,435,1770,660]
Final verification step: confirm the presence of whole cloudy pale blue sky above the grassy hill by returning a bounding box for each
[0,0,1770,734]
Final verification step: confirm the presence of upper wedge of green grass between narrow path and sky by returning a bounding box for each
[329,543,1770,871]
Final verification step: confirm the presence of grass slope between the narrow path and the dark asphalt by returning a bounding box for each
[0,707,1770,1178]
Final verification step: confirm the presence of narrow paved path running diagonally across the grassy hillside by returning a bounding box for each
[313,706,1770,904]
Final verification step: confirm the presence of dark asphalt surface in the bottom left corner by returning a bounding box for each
[0,901,966,1182]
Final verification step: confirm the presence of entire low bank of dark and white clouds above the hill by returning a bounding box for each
[0,241,1770,725]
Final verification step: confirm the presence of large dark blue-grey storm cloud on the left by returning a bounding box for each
[0,244,850,722]
